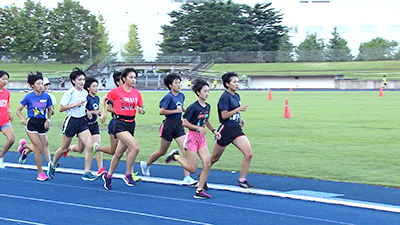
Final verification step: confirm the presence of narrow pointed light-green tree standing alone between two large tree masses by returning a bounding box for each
[93,15,115,62]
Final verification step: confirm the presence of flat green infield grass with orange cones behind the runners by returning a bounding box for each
[0,91,400,187]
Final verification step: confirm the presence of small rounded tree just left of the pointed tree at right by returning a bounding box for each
[296,34,325,62]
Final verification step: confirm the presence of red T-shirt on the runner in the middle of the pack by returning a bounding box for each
[107,86,143,116]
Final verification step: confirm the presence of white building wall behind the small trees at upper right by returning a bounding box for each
[266,0,400,56]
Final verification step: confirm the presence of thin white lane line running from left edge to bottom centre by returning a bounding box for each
[0,194,209,225]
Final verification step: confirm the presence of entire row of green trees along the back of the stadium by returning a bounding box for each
[0,0,400,63]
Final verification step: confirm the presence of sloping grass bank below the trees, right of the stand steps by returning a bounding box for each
[208,60,400,79]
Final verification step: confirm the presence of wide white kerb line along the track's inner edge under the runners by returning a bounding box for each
[5,163,400,213]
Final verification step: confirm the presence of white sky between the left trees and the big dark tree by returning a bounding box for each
[0,0,265,60]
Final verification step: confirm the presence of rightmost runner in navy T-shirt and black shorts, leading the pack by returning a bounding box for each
[211,72,253,188]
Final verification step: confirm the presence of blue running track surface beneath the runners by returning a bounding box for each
[0,152,400,224]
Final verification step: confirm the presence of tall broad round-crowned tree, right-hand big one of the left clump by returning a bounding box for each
[48,0,102,63]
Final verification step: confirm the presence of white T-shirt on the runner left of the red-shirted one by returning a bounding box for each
[60,87,88,118]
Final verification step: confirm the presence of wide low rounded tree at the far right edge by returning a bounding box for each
[357,37,399,61]
